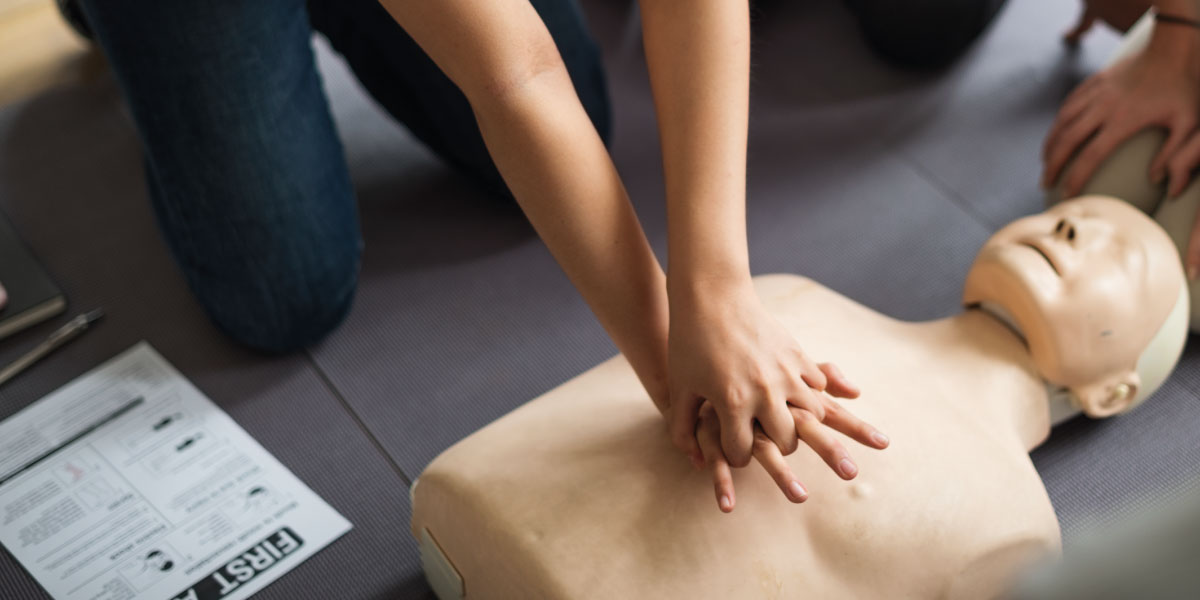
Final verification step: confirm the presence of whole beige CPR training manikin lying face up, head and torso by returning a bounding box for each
[412,197,1188,599]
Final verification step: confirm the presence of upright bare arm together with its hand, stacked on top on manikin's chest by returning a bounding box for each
[641,0,844,467]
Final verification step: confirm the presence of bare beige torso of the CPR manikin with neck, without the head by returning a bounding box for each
[413,275,1061,599]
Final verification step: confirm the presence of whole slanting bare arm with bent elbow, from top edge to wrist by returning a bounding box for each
[383,0,667,410]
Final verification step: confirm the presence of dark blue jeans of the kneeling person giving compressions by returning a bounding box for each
[80,0,608,352]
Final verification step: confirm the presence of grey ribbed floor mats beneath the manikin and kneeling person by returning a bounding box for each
[0,0,1200,598]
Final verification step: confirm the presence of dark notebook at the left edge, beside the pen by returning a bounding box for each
[0,210,67,338]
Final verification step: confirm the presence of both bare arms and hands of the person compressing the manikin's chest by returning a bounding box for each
[383,0,883,499]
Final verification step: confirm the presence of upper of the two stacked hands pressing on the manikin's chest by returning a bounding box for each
[667,278,858,467]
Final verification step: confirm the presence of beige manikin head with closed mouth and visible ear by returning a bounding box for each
[964,196,1188,418]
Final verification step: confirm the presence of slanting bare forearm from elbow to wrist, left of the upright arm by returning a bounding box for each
[475,72,667,409]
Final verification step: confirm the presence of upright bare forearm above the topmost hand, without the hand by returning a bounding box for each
[641,0,750,293]
